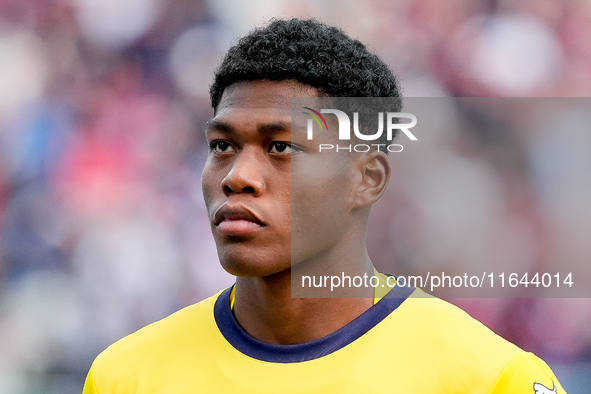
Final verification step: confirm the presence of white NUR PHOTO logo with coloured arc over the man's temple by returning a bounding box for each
[303,107,418,152]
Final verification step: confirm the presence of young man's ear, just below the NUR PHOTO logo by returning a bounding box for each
[354,151,391,208]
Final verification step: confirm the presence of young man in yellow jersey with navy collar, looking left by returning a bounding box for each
[84,20,564,394]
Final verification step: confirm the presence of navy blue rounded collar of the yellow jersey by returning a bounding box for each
[214,286,415,363]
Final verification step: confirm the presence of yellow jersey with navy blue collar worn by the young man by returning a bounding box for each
[84,278,565,394]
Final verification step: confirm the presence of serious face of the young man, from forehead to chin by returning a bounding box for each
[202,81,355,277]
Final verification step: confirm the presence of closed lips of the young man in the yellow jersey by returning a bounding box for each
[213,204,266,237]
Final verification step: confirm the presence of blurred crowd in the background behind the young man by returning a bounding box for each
[0,0,591,393]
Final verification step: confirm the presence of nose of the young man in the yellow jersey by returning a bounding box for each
[222,149,265,197]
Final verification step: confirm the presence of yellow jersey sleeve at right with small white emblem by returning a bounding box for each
[489,352,566,394]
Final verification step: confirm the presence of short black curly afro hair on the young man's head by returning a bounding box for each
[210,19,401,110]
